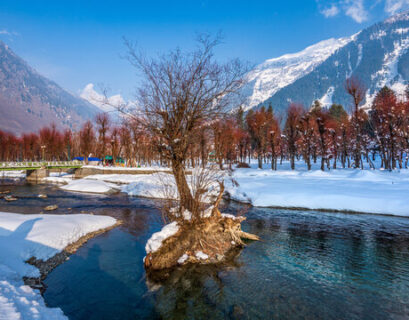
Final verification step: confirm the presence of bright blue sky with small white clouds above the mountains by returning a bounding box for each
[0,0,409,99]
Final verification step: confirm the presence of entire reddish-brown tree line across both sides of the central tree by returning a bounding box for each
[0,78,409,170]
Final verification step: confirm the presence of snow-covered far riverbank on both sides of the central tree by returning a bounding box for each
[40,159,409,216]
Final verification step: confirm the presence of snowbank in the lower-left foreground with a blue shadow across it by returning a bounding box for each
[0,212,116,320]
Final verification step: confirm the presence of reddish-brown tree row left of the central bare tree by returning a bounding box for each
[0,113,156,165]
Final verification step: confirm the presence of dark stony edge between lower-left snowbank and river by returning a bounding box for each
[23,220,123,295]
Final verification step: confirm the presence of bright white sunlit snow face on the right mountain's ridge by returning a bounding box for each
[244,35,355,110]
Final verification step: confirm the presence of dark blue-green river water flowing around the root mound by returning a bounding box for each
[0,185,409,319]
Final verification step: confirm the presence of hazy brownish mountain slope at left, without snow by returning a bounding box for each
[0,41,100,133]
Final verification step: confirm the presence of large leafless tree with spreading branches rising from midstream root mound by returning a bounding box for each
[126,36,247,220]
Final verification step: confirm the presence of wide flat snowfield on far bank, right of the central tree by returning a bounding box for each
[225,162,409,216]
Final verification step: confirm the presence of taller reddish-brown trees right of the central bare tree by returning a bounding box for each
[213,78,409,170]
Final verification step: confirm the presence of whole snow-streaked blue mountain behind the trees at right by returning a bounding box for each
[243,12,409,112]
